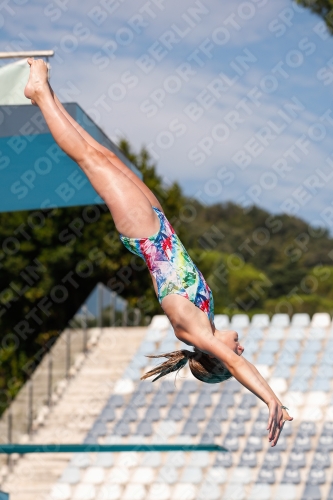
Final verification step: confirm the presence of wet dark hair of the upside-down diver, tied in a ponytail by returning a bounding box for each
[141,349,232,384]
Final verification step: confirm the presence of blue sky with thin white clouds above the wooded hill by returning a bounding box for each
[0,0,333,230]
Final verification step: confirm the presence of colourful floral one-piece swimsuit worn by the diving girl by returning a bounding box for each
[120,207,214,322]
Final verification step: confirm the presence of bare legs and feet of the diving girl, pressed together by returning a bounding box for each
[25,60,159,238]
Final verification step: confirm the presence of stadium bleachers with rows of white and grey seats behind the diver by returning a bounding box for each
[45,313,333,500]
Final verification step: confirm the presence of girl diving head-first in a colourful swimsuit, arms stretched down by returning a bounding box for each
[24,59,292,446]
